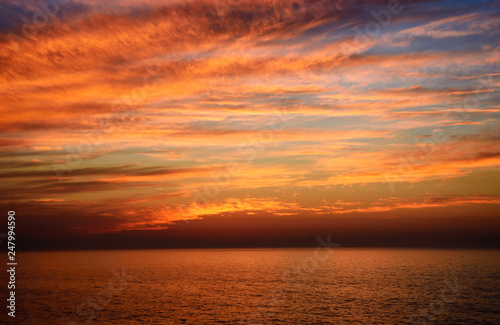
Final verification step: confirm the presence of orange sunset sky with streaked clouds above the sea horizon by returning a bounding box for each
[0,0,500,249]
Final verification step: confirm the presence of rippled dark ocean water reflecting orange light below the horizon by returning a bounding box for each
[6,248,500,325]
